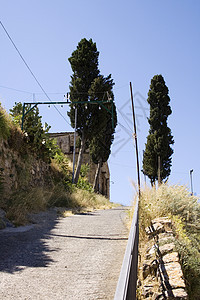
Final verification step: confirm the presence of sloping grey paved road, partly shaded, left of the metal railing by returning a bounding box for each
[0,207,128,300]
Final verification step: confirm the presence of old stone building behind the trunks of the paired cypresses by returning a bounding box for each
[50,132,110,198]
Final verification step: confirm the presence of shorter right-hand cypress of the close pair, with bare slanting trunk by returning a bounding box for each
[89,75,117,191]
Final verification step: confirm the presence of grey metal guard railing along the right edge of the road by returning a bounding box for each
[114,199,139,300]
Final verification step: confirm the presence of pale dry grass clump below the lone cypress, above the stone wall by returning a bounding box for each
[140,184,200,234]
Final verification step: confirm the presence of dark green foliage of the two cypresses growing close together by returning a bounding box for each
[68,39,116,183]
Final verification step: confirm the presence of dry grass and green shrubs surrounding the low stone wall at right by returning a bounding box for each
[140,184,200,300]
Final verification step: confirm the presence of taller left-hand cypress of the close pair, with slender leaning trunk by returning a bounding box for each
[68,38,102,183]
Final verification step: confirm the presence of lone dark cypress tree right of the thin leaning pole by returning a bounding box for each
[143,75,174,185]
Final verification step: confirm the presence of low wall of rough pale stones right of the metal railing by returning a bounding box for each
[140,218,188,300]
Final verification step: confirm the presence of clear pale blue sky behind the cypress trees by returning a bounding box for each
[0,0,200,205]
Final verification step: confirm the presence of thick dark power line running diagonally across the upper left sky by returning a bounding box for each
[0,21,71,126]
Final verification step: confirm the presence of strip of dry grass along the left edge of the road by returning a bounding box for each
[3,184,115,226]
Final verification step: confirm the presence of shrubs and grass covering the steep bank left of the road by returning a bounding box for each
[0,103,112,225]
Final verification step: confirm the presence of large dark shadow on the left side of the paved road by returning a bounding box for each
[0,211,58,273]
